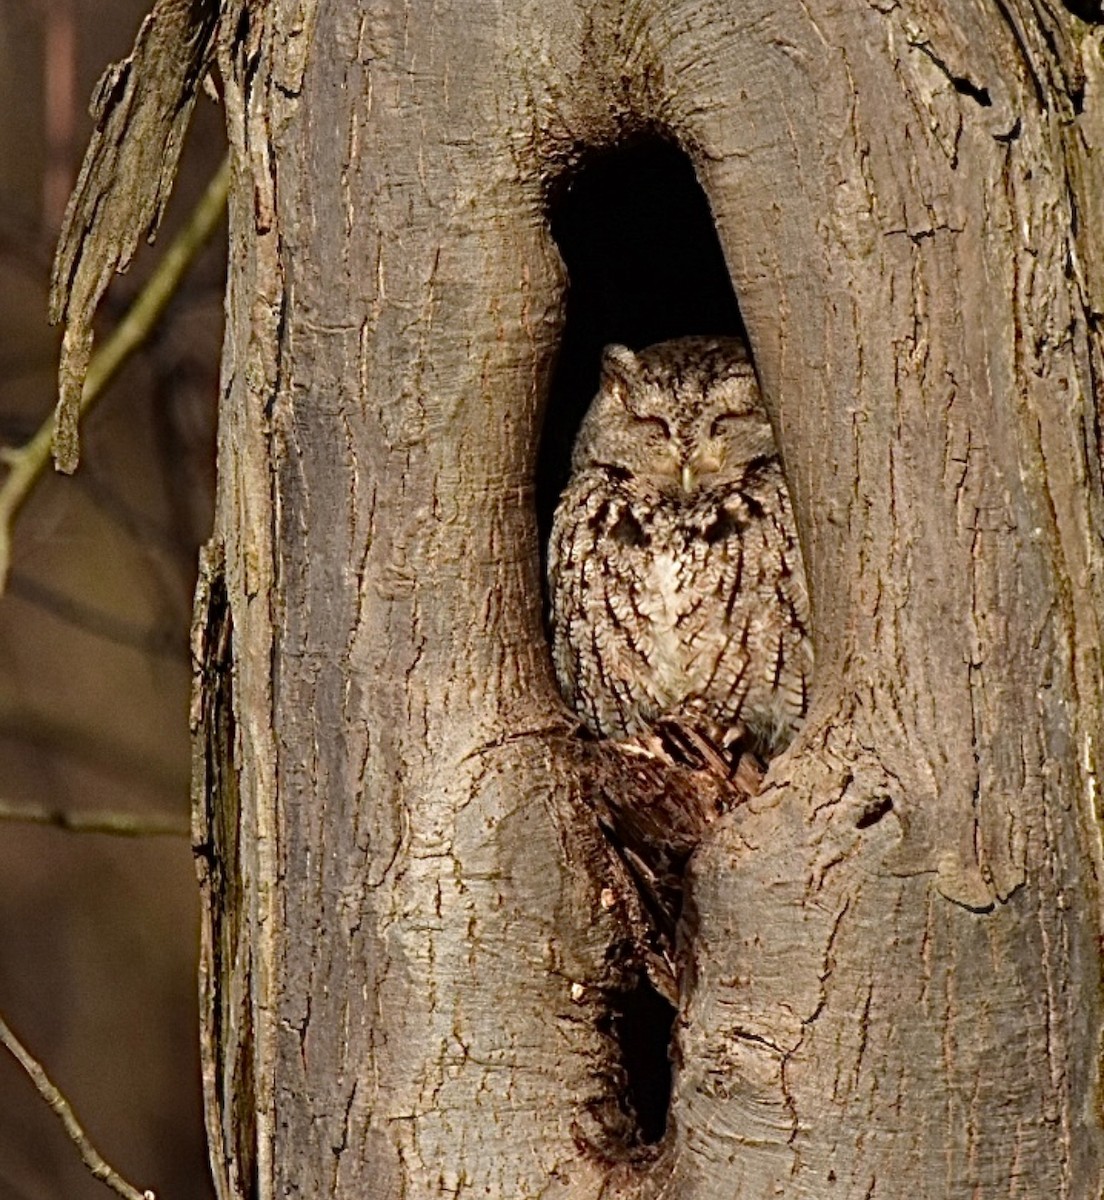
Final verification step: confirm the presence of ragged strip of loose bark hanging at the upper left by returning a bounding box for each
[49,0,220,473]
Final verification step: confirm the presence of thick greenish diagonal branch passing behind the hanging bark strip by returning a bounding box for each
[0,158,230,594]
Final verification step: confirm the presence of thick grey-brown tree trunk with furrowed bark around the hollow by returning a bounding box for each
[189,0,1104,1200]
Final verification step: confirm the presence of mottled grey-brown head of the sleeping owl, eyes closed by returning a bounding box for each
[572,337,776,496]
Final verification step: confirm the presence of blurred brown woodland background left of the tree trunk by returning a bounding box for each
[0,0,224,1200]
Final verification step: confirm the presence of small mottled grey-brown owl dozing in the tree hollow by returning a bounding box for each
[548,337,812,756]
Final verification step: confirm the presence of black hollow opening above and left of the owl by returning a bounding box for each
[536,137,744,545]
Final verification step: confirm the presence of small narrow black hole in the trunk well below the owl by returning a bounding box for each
[611,973,676,1145]
